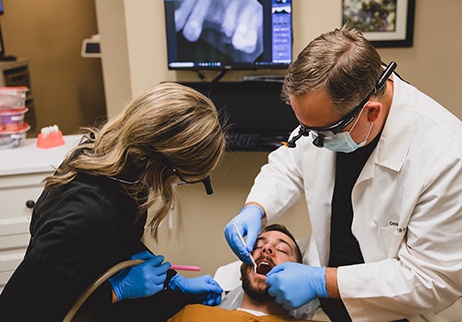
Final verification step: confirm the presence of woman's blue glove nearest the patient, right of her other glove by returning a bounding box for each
[168,274,223,306]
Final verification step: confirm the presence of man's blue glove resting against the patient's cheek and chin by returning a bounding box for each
[266,262,328,310]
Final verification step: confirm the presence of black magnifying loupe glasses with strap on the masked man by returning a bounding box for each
[286,61,397,148]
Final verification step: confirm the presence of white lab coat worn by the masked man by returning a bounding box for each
[247,76,462,321]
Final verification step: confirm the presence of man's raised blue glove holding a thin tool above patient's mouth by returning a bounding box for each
[225,206,263,264]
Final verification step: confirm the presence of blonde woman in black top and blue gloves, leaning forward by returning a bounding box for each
[0,83,225,321]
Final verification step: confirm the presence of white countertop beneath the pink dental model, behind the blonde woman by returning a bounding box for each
[0,135,82,176]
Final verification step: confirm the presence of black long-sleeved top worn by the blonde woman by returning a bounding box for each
[0,174,192,321]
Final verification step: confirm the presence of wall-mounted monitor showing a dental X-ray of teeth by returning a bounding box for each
[164,0,292,70]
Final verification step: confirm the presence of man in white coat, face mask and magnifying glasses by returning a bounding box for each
[225,26,462,321]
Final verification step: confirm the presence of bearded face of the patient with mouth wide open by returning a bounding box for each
[241,231,297,302]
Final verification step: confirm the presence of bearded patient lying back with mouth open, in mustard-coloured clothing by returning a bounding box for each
[168,224,312,322]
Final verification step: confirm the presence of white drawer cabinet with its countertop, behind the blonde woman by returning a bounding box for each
[0,135,81,292]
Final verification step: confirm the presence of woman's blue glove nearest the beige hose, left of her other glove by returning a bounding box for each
[109,251,170,301]
